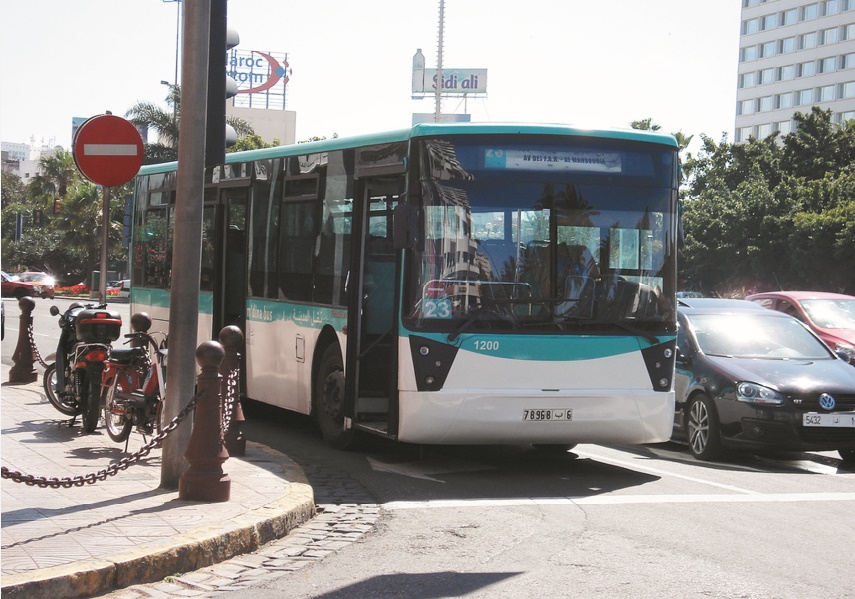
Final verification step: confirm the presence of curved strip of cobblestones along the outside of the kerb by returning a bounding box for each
[94,466,381,599]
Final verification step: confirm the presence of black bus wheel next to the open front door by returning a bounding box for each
[314,344,354,449]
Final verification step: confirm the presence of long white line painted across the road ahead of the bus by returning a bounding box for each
[381,493,855,510]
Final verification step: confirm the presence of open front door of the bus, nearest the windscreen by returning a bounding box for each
[345,176,404,436]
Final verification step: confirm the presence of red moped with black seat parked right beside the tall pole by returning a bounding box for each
[101,312,167,443]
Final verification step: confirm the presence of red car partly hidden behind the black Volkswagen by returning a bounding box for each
[745,291,855,365]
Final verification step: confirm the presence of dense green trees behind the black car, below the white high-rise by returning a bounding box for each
[680,108,855,294]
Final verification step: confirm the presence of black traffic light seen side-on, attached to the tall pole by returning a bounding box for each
[205,0,240,166]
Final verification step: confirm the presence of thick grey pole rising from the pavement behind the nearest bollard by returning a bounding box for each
[160,0,211,489]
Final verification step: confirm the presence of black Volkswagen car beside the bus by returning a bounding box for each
[673,302,855,463]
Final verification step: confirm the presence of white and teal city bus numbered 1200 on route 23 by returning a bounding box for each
[131,123,678,448]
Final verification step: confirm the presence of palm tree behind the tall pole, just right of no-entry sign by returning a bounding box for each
[125,84,255,164]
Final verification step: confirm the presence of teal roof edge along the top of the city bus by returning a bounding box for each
[138,123,677,175]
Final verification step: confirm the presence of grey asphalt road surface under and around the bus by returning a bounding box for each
[8,300,855,599]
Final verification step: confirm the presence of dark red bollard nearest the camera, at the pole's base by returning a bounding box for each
[178,341,232,501]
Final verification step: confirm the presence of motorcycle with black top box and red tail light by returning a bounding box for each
[43,302,122,433]
